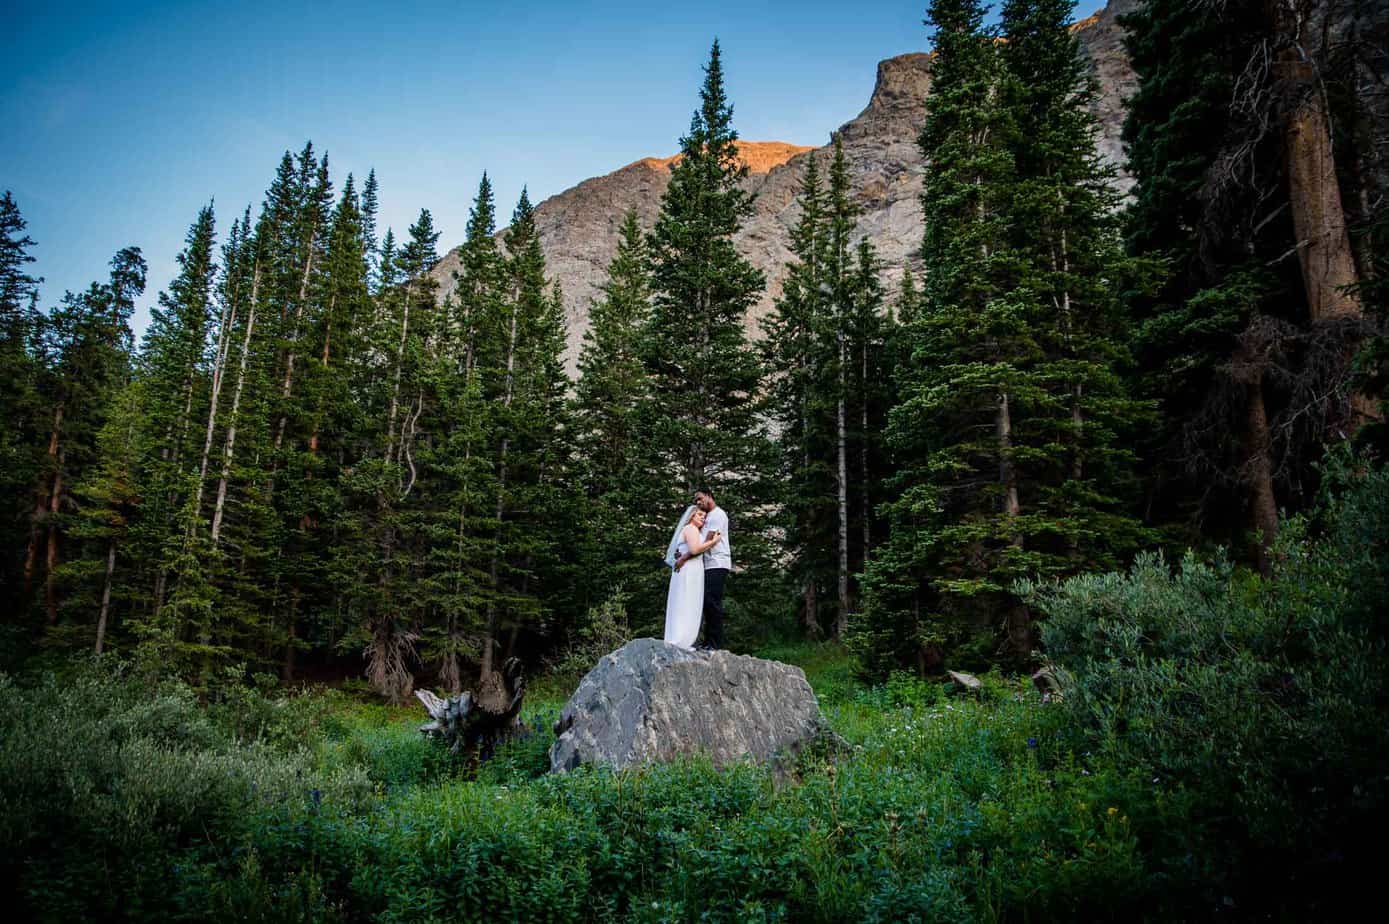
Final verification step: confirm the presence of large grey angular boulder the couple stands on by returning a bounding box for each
[550,639,833,771]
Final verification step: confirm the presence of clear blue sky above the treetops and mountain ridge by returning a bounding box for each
[0,0,1103,327]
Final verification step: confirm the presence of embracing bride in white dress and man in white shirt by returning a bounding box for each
[665,488,733,652]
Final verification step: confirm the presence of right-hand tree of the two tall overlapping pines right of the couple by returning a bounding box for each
[1001,0,1153,570]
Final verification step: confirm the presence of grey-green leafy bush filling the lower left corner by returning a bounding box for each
[0,664,371,918]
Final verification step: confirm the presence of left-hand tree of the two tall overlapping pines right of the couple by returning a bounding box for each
[854,0,1028,671]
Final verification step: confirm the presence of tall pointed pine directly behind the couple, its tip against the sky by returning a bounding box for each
[642,42,772,628]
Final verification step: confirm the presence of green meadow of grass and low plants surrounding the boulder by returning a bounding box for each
[0,645,1165,921]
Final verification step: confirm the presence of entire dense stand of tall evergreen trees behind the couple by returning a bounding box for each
[0,0,1389,691]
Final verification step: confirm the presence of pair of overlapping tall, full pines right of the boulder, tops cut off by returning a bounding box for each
[858,0,1142,667]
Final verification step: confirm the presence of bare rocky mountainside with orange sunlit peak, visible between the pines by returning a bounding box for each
[435,0,1138,374]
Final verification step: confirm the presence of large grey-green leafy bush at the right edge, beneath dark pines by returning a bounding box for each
[1020,450,1389,910]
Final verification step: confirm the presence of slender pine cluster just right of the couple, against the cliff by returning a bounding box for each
[761,135,889,636]
